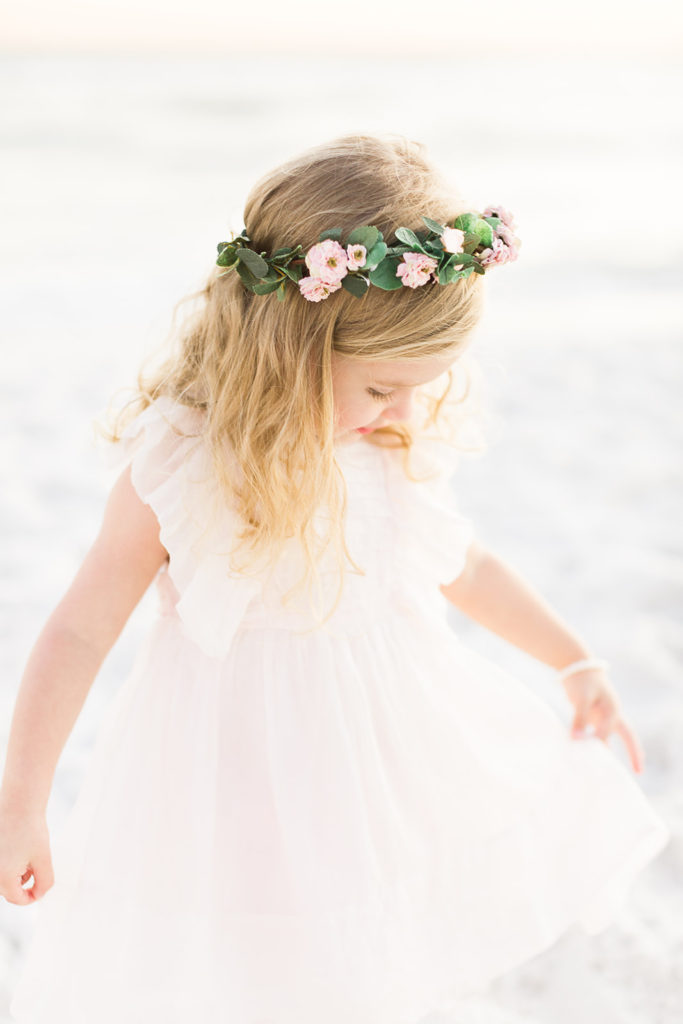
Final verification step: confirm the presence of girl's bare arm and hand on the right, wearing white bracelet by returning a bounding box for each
[439,541,644,772]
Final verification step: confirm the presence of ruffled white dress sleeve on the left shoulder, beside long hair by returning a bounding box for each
[98,395,261,657]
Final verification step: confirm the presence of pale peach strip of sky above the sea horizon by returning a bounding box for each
[0,0,683,57]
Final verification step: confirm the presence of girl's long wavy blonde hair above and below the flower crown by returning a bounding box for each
[98,134,489,622]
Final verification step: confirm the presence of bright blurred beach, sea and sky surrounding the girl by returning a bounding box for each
[0,0,683,1024]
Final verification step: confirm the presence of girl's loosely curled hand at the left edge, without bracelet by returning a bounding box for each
[0,799,54,905]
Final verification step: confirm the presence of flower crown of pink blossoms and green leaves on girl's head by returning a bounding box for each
[216,206,521,302]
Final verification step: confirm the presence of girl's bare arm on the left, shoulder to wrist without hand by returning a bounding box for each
[0,467,167,815]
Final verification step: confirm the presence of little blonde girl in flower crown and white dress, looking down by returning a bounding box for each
[0,135,669,1024]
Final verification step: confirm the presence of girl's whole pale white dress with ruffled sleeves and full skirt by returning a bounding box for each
[10,397,670,1024]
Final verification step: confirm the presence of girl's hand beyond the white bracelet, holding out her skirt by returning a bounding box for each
[562,669,644,773]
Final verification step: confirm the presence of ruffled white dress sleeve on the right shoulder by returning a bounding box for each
[388,437,474,585]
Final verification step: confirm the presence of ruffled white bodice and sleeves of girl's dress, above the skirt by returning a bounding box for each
[102,396,472,657]
